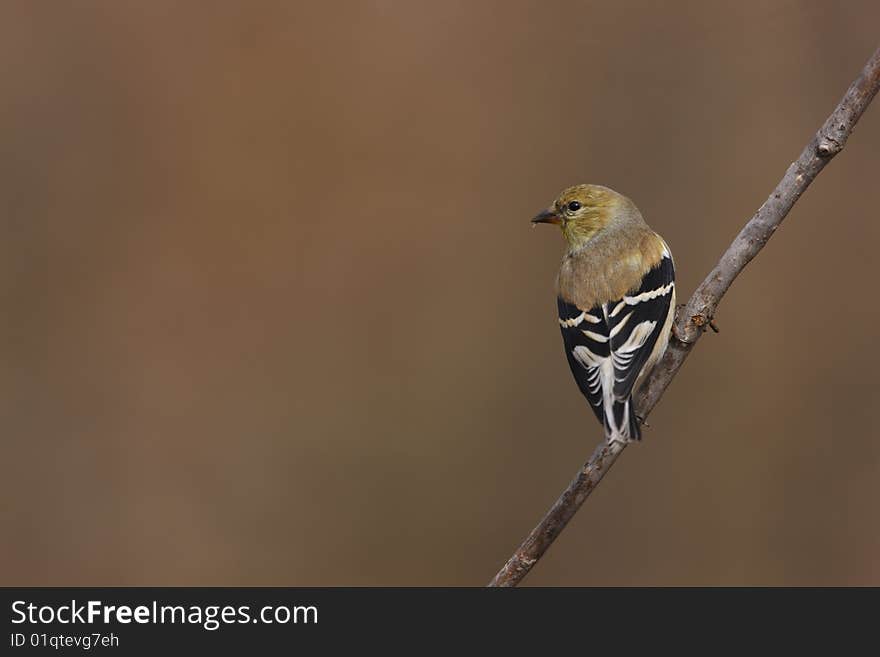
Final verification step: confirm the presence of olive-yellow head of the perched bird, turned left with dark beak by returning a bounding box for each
[532,185,629,249]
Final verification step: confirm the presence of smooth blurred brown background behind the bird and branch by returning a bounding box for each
[0,0,880,585]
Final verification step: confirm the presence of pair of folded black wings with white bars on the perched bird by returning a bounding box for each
[557,254,675,432]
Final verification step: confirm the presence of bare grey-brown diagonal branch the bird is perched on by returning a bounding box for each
[489,49,880,586]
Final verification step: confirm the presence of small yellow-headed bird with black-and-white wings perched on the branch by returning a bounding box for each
[532,184,675,444]
